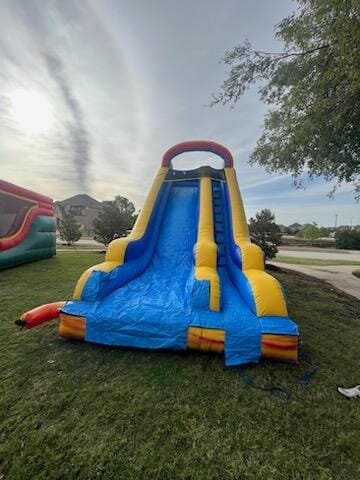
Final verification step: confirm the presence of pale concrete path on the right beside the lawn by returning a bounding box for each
[269,262,360,300]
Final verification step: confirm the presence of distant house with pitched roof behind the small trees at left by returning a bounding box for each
[54,193,102,235]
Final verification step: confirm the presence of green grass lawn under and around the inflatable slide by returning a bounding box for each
[0,252,360,480]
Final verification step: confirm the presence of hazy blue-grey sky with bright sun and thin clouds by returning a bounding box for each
[0,0,360,225]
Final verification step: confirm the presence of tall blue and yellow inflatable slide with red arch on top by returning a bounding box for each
[22,141,299,366]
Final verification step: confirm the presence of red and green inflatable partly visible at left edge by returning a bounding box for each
[0,180,56,270]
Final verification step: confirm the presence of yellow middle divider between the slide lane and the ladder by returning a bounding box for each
[195,177,220,311]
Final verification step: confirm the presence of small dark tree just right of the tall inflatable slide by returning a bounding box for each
[249,209,281,260]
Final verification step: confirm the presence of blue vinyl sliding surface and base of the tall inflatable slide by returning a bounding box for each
[62,180,261,365]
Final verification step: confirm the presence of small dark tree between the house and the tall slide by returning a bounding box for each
[93,196,135,245]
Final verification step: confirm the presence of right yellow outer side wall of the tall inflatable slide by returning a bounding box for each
[225,168,288,317]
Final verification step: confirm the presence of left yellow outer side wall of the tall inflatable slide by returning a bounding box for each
[73,167,169,300]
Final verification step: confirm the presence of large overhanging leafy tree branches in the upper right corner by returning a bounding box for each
[212,0,360,199]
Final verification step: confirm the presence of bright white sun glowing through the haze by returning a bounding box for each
[10,91,54,134]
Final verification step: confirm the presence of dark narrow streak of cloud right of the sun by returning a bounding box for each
[43,52,91,191]
